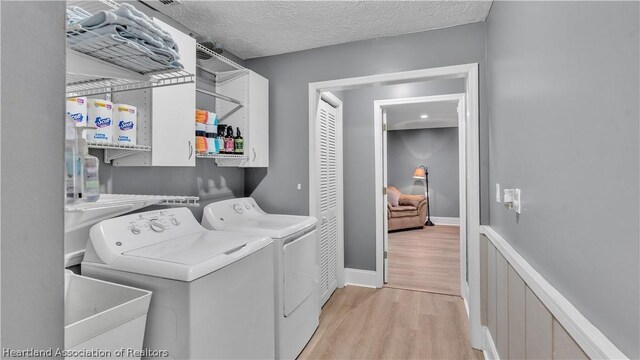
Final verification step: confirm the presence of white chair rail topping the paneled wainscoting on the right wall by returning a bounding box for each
[480,225,627,359]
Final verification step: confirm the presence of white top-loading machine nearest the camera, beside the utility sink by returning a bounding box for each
[82,208,275,359]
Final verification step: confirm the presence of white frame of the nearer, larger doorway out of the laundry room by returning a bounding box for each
[309,63,483,349]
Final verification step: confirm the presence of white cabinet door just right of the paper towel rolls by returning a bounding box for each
[151,19,196,166]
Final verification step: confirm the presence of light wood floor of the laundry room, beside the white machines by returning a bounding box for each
[298,286,483,359]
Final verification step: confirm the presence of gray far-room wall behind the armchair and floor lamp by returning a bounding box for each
[387,128,460,218]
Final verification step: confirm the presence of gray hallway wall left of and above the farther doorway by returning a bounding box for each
[342,79,465,270]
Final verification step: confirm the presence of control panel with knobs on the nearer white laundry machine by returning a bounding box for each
[89,208,207,264]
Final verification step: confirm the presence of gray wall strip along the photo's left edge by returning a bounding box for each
[0,1,65,349]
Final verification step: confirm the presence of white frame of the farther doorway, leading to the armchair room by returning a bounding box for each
[373,94,469,290]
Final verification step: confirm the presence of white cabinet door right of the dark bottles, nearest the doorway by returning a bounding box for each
[243,71,269,167]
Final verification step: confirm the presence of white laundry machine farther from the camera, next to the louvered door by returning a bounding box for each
[202,198,320,359]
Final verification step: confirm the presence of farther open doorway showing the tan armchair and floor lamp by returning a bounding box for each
[374,94,467,296]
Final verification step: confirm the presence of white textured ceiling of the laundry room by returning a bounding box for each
[144,0,491,59]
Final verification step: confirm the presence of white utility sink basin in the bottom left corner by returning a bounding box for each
[64,270,151,359]
